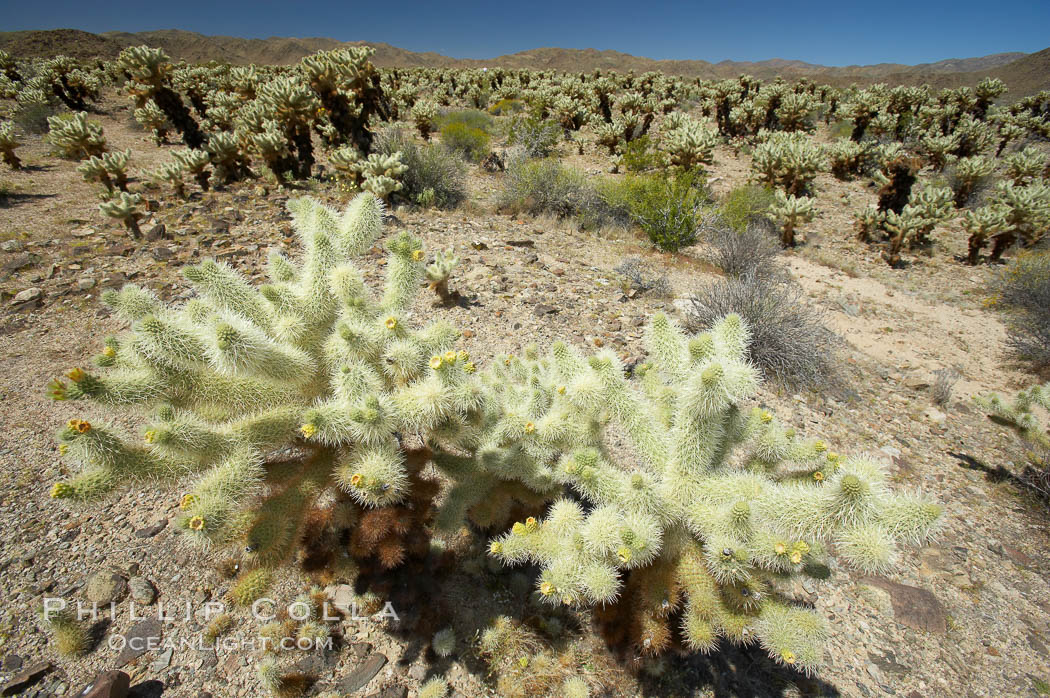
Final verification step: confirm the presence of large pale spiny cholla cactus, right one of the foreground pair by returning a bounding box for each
[490,315,941,671]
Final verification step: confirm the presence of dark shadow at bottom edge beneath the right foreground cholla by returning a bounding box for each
[643,643,842,698]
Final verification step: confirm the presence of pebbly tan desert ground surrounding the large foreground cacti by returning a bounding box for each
[0,102,1050,698]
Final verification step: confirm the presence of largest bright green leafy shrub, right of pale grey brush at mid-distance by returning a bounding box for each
[602,170,708,252]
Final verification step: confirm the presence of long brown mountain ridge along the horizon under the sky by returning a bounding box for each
[0,29,1050,97]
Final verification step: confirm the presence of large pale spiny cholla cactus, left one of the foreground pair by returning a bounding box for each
[51,194,512,565]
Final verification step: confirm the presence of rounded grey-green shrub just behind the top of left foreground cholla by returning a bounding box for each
[376,129,466,209]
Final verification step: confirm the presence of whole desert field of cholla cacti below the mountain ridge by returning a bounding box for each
[0,38,1050,696]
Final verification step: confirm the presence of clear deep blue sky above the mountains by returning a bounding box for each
[8,0,1050,65]
